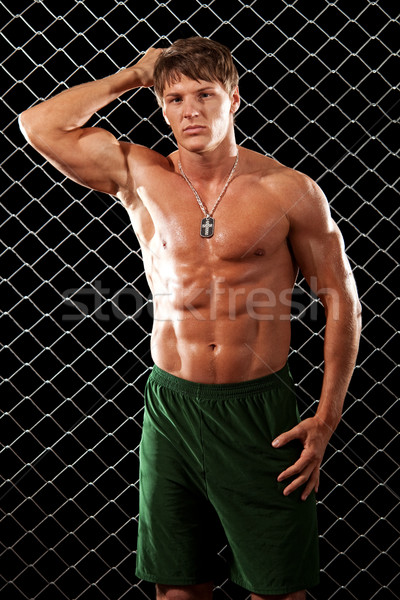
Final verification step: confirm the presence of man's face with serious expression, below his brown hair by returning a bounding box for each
[163,75,239,152]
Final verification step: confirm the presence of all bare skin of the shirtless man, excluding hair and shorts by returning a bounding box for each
[20,48,361,600]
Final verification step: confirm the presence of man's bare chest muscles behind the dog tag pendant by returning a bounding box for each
[136,171,289,260]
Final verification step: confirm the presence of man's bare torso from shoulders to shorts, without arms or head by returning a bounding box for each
[119,148,297,383]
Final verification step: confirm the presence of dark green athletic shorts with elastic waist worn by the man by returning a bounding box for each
[136,366,319,594]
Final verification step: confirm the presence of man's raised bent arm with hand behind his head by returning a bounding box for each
[19,48,162,195]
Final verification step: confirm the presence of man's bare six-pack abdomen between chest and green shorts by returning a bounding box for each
[147,264,293,384]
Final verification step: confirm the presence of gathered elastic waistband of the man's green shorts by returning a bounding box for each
[149,363,293,398]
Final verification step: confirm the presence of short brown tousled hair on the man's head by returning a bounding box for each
[154,37,239,106]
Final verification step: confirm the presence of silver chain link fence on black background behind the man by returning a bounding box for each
[0,0,400,600]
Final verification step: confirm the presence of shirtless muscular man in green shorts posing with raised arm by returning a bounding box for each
[20,38,360,600]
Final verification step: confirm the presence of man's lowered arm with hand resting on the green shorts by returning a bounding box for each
[272,172,361,500]
